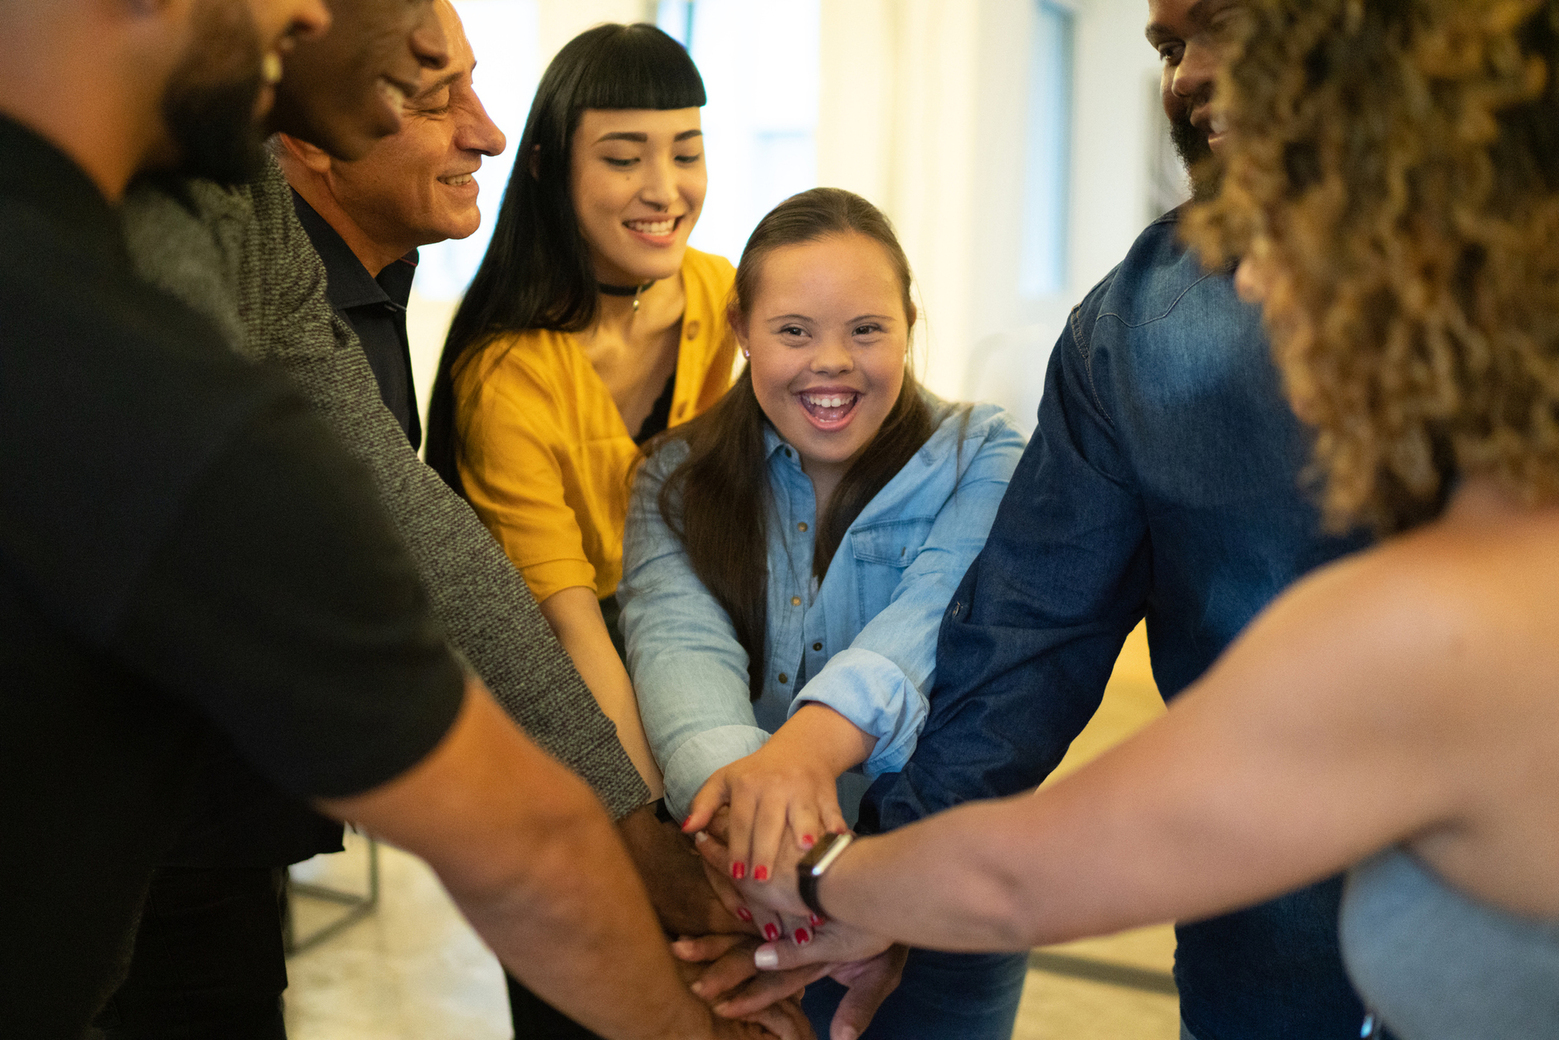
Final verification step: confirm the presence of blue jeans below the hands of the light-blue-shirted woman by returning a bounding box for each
[801,950,1029,1040]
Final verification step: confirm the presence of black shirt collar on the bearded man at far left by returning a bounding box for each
[0,115,129,267]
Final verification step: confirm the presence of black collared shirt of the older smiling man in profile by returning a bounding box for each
[293,192,422,447]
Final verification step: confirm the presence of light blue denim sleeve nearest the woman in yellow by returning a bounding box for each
[617,441,769,819]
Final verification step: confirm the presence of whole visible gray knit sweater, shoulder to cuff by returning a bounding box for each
[125,164,649,819]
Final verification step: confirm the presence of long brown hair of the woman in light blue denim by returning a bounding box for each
[644,187,942,700]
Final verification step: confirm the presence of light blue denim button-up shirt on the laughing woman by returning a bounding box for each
[617,399,1024,819]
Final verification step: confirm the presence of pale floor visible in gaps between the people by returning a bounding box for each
[287,628,1179,1040]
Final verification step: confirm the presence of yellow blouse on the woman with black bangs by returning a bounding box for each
[454,249,736,600]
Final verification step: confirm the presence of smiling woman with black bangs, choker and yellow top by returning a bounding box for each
[427,25,736,1037]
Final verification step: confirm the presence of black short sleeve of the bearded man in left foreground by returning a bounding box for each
[115,399,465,797]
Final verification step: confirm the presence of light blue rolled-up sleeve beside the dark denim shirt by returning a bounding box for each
[790,415,1024,776]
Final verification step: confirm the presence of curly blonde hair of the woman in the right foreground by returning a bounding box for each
[1186,0,1559,533]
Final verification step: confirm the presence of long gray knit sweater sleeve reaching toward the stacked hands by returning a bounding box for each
[135,165,649,819]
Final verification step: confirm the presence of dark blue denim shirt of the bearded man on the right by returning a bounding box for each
[867,214,1364,1040]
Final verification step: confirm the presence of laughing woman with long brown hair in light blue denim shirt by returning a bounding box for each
[619,189,1024,1040]
